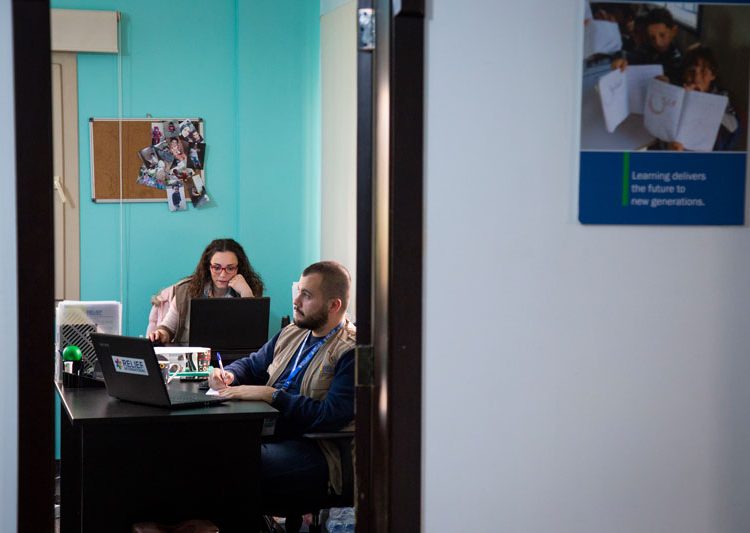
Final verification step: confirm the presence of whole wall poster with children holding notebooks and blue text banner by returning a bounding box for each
[578,0,750,225]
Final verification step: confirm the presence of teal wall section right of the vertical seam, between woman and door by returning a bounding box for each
[237,0,320,329]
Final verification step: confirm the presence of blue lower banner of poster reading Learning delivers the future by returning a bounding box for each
[579,152,747,224]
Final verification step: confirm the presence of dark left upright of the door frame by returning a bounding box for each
[11,0,55,531]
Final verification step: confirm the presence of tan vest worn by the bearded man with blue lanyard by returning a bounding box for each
[267,320,357,494]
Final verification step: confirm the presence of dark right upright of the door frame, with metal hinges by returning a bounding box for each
[357,0,425,533]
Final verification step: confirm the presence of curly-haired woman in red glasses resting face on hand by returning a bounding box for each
[148,239,263,343]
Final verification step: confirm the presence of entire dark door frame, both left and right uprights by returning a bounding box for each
[11,0,424,532]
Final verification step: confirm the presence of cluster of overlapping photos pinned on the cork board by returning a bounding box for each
[136,119,210,211]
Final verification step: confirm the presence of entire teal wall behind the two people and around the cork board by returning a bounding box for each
[52,0,320,335]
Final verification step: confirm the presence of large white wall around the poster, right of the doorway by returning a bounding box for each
[423,0,750,533]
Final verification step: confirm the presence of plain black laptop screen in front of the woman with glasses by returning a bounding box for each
[189,297,271,357]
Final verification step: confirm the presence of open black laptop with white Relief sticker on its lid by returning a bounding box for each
[90,333,226,409]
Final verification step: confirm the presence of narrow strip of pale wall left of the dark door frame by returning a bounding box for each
[0,0,18,531]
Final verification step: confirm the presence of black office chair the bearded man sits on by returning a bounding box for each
[264,431,354,533]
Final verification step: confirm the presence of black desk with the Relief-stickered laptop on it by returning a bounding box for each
[56,383,278,533]
